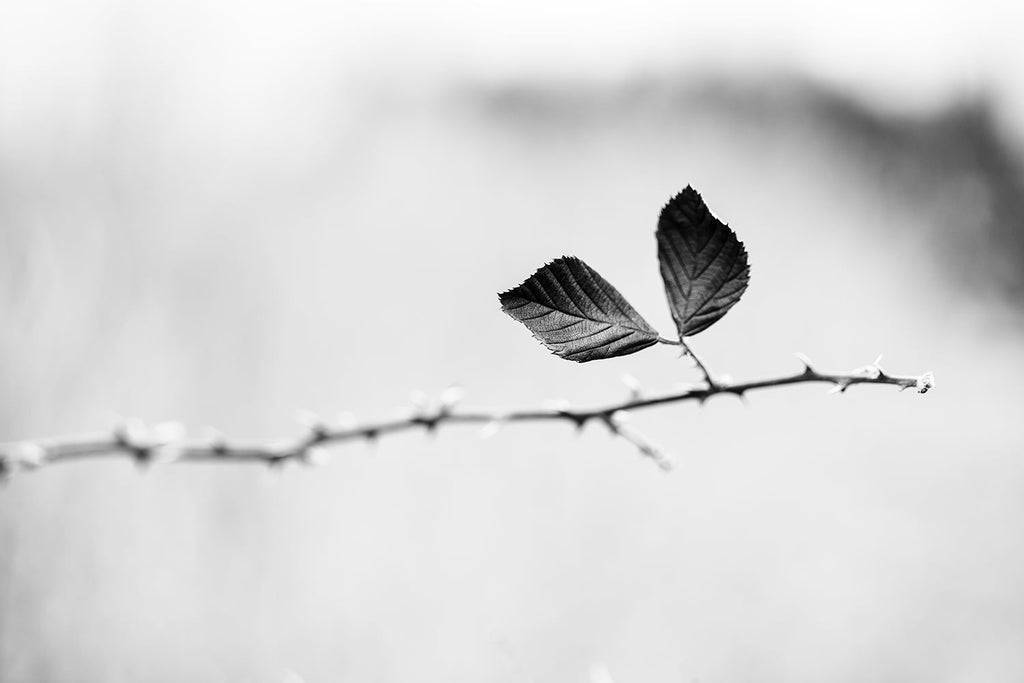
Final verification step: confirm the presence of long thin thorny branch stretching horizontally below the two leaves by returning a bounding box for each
[0,356,935,477]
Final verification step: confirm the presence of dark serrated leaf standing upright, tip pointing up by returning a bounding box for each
[657,185,751,339]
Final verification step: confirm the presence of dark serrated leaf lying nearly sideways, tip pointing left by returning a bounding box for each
[498,256,658,362]
